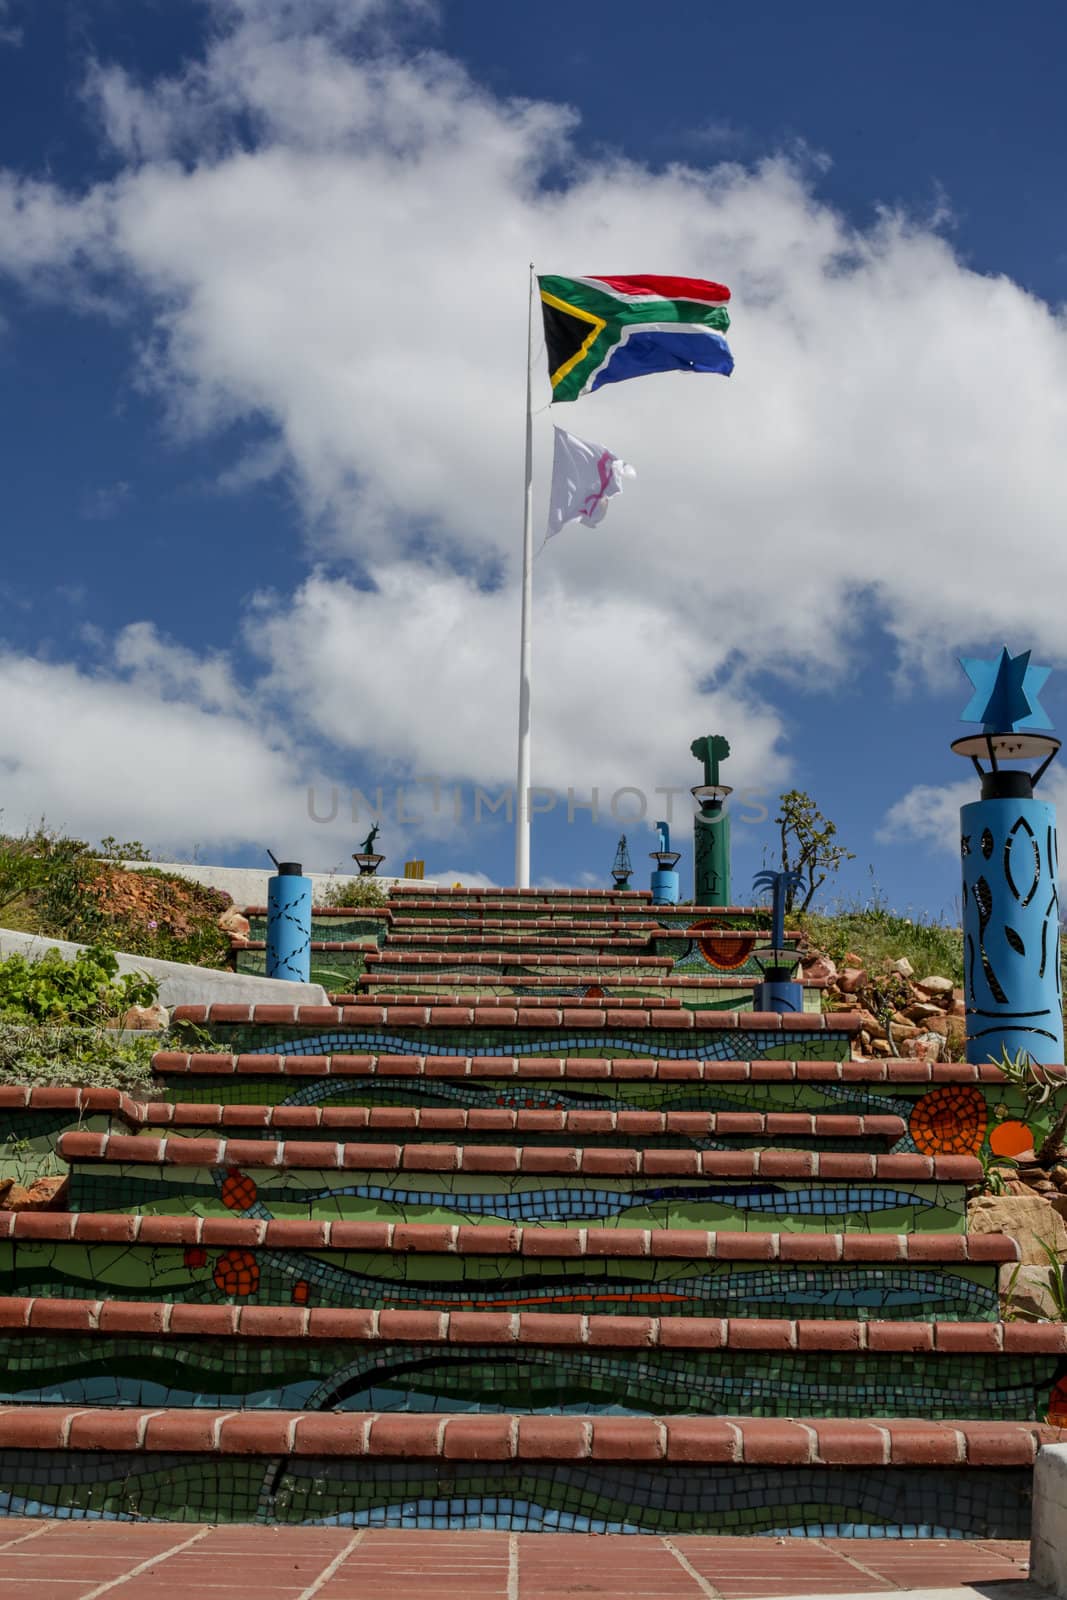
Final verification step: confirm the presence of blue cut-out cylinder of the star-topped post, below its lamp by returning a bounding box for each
[960,768,1064,1064]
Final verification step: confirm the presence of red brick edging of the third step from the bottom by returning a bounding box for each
[0,1211,1021,1266]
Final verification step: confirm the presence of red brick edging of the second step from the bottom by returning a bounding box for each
[0,1296,1067,1355]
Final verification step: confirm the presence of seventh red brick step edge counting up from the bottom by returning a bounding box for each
[171,1002,862,1035]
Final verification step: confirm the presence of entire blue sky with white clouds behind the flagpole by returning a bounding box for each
[0,0,1067,914]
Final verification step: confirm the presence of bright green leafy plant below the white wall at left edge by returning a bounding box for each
[0,946,158,1024]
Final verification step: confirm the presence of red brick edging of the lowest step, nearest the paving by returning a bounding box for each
[0,1405,1064,1467]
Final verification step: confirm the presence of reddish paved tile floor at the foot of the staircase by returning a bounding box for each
[0,1518,1037,1600]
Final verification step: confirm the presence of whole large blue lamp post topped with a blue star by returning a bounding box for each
[952,648,1064,1066]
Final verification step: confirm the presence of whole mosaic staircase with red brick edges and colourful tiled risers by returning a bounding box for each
[0,886,1067,1538]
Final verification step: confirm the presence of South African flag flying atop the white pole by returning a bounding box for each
[537,272,734,400]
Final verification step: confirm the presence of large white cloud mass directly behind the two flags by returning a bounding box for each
[0,0,1067,864]
